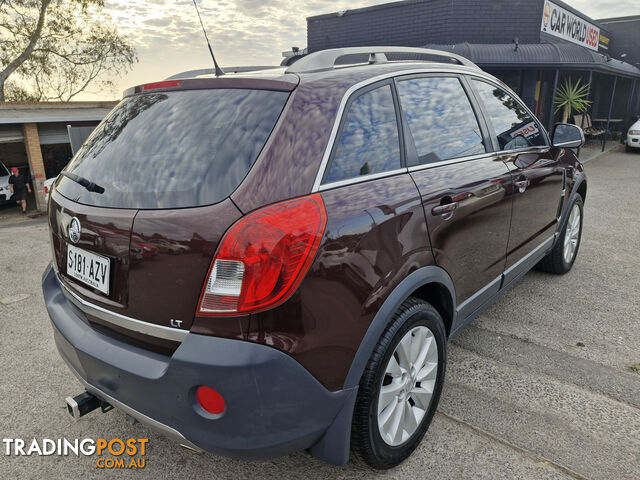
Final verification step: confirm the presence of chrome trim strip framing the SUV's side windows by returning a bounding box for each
[311,66,500,193]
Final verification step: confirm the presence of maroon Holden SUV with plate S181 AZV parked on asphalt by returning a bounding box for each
[43,47,587,468]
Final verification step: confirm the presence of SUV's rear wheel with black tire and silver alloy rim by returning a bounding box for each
[351,297,447,470]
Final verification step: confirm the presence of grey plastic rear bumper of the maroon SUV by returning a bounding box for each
[42,267,355,460]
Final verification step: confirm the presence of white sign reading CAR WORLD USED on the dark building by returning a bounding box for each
[540,1,600,51]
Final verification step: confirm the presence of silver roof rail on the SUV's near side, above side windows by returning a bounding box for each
[286,47,479,73]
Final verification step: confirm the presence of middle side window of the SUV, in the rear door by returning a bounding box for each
[398,78,485,164]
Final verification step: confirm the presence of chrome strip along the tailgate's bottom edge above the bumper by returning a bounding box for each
[56,272,189,342]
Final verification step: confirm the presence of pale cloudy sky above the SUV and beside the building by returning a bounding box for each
[77,0,640,100]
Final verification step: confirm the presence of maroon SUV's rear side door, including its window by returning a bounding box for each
[396,75,511,319]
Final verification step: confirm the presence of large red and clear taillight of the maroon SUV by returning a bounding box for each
[197,193,327,315]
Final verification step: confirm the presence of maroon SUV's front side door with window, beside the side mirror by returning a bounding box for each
[470,78,565,284]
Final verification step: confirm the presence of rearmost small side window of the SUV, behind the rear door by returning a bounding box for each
[323,84,401,183]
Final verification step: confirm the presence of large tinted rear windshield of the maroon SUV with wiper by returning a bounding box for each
[57,89,289,209]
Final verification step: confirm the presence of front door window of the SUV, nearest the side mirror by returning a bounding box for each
[472,79,547,150]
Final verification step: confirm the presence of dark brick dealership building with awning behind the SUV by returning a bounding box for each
[302,0,640,135]
